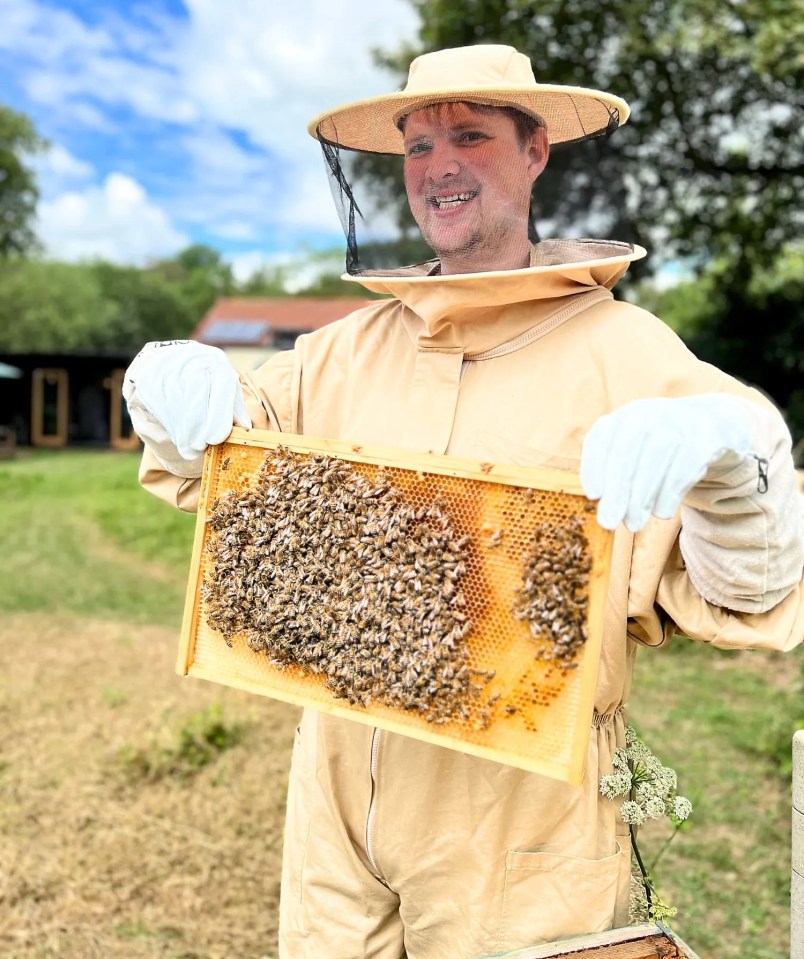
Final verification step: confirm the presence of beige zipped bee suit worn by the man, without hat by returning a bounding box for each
[142,244,804,959]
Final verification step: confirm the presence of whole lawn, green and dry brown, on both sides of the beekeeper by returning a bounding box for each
[0,451,804,959]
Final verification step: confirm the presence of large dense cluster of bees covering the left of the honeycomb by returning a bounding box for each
[202,447,482,723]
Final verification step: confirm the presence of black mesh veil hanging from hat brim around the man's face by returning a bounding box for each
[311,98,620,275]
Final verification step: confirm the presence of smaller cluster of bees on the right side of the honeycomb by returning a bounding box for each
[513,516,592,669]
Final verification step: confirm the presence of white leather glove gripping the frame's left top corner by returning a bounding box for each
[123,340,251,477]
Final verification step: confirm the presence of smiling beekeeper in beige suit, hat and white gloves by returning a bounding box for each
[124,45,804,959]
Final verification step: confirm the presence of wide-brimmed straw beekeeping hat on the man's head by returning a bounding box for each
[308,44,629,154]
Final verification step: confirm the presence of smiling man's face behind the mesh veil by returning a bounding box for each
[404,103,547,272]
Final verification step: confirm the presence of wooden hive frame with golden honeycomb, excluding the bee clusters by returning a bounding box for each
[177,428,612,785]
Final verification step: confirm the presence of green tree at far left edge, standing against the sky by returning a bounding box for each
[0,104,45,259]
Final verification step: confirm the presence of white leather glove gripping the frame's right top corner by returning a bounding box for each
[581,393,754,533]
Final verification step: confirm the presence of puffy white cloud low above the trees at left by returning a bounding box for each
[39,173,189,264]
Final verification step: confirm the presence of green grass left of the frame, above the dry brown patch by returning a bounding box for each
[0,451,195,624]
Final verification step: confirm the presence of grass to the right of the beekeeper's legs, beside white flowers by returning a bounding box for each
[630,638,804,959]
